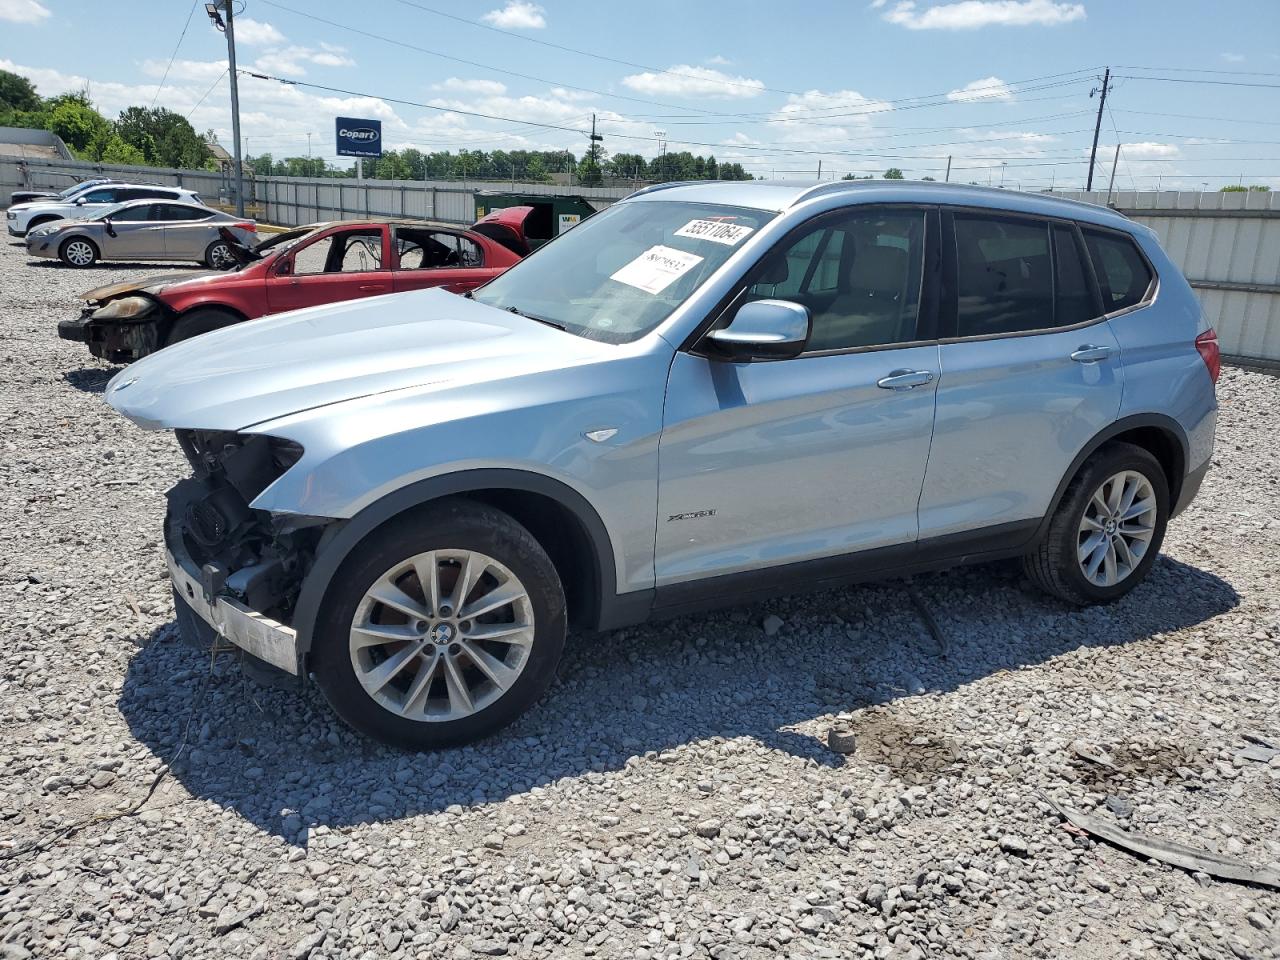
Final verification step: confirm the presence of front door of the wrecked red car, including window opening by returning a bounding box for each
[266,224,392,314]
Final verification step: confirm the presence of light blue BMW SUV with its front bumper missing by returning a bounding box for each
[106,182,1219,748]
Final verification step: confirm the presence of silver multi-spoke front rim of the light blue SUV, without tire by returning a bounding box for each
[349,549,534,722]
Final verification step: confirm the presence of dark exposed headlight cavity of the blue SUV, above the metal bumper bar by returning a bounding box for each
[166,430,332,622]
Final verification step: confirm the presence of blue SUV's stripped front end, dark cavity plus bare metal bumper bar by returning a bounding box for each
[165,430,333,676]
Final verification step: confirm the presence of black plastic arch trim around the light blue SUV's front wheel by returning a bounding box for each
[293,468,640,655]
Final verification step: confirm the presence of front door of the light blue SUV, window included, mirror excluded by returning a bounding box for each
[655,206,938,589]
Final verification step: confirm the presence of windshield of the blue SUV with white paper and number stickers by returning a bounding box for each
[474,201,774,343]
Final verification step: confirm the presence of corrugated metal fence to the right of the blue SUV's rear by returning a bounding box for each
[1065,191,1280,362]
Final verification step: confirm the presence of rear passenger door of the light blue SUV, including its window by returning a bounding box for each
[920,210,1123,541]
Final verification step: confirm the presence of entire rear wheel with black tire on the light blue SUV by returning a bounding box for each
[1023,442,1169,605]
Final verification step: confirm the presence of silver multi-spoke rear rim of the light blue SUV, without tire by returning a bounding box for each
[1076,470,1157,586]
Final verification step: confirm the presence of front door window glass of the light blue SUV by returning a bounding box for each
[748,207,925,352]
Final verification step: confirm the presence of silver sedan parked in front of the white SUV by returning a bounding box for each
[27,200,257,270]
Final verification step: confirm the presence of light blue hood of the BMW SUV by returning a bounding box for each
[106,289,609,430]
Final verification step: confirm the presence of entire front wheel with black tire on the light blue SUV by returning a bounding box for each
[311,498,566,750]
